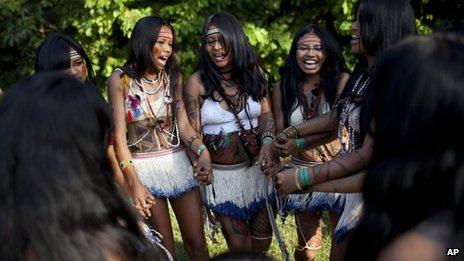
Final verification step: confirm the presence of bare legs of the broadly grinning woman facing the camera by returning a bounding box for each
[294,212,322,260]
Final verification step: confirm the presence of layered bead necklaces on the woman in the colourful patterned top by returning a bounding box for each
[128,71,180,149]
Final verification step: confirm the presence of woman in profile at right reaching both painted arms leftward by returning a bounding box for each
[277,0,416,259]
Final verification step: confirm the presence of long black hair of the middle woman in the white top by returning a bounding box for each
[198,12,268,101]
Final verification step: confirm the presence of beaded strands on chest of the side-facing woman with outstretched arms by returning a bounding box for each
[337,73,371,153]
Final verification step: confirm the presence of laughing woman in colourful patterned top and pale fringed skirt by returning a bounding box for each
[108,16,211,260]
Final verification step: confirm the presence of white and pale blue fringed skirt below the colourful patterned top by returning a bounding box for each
[132,147,198,198]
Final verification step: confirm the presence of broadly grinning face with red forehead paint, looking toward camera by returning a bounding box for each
[296,32,325,74]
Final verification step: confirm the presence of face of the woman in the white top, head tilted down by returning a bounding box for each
[205,26,231,71]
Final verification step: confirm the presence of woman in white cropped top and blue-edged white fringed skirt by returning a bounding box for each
[184,13,275,251]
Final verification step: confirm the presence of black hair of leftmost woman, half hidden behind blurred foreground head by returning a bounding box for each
[35,33,94,81]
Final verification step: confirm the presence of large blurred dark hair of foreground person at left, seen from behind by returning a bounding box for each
[0,72,160,260]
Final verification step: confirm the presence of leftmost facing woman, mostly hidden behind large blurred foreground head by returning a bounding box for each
[35,33,141,205]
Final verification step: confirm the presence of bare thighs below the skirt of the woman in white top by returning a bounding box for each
[214,212,253,251]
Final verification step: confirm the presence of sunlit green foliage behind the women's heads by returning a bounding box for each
[0,0,450,93]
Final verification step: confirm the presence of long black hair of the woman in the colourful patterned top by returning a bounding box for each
[122,16,181,98]
